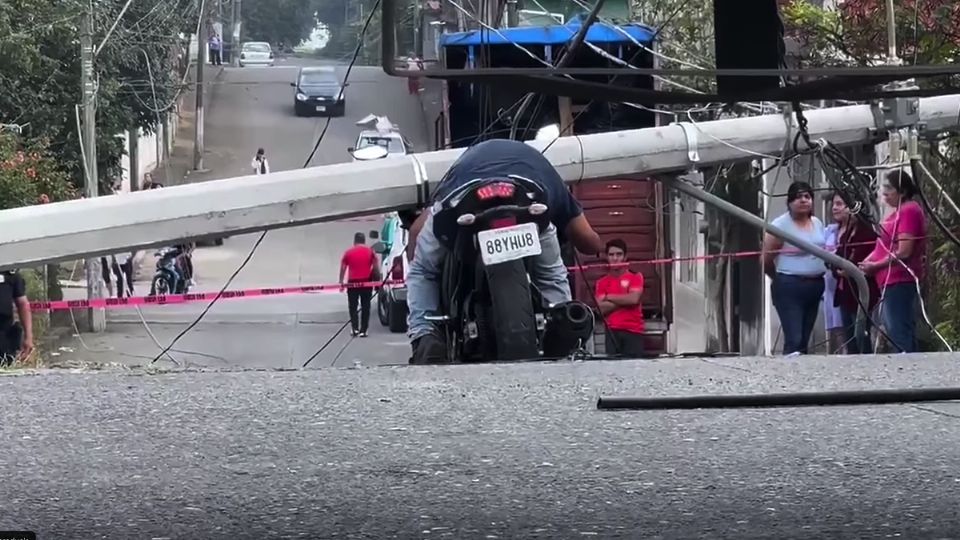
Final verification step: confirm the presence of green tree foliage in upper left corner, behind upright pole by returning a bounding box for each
[0,0,197,196]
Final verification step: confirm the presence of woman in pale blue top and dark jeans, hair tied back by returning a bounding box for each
[763,182,827,355]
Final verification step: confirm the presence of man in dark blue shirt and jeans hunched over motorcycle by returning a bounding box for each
[406,139,604,364]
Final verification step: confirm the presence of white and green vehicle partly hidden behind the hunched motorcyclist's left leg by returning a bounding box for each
[370,212,410,333]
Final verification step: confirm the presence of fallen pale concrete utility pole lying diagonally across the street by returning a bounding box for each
[0,95,960,269]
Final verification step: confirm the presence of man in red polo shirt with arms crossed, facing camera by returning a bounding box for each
[596,238,643,357]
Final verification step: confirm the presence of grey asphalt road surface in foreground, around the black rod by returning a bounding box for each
[0,355,960,540]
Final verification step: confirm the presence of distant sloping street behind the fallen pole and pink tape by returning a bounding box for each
[58,58,427,368]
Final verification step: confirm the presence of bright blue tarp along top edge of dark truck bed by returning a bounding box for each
[440,17,655,47]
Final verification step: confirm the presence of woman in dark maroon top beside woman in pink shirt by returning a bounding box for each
[832,193,880,354]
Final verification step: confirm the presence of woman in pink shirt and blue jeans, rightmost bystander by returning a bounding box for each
[860,170,927,352]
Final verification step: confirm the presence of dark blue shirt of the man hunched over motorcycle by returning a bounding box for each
[433,139,583,243]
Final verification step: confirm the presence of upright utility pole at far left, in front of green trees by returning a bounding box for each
[79,8,107,332]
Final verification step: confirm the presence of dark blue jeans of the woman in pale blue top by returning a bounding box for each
[770,272,825,354]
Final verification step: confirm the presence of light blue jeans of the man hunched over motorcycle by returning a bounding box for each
[406,212,572,341]
